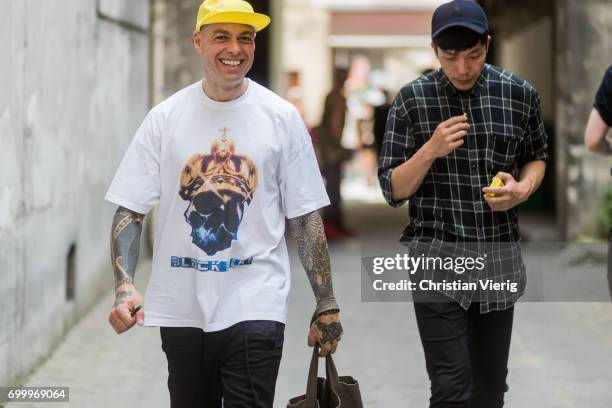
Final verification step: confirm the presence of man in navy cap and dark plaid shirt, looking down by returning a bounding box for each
[378,0,548,408]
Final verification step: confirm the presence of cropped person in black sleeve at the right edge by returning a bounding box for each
[584,65,612,299]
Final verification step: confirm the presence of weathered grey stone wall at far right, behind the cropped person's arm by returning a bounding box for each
[555,0,612,238]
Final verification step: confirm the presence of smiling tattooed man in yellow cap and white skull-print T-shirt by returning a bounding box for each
[106,0,342,408]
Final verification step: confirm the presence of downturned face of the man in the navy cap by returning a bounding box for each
[433,37,491,91]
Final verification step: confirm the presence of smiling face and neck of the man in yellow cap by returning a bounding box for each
[193,23,255,99]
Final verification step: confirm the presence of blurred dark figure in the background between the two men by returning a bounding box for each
[315,68,352,240]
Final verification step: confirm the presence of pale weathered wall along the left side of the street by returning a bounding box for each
[0,0,150,385]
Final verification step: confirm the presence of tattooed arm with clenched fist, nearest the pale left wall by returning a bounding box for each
[108,207,144,333]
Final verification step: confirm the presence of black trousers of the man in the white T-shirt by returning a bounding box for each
[160,320,285,408]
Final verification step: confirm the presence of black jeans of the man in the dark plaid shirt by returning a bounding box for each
[414,302,514,408]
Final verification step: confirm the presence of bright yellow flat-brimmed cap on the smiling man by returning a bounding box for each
[196,0,270,32]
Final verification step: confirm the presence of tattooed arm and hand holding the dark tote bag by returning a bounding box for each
[288,211,342,357]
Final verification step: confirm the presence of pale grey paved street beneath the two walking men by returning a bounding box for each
[7,204,612,408]
